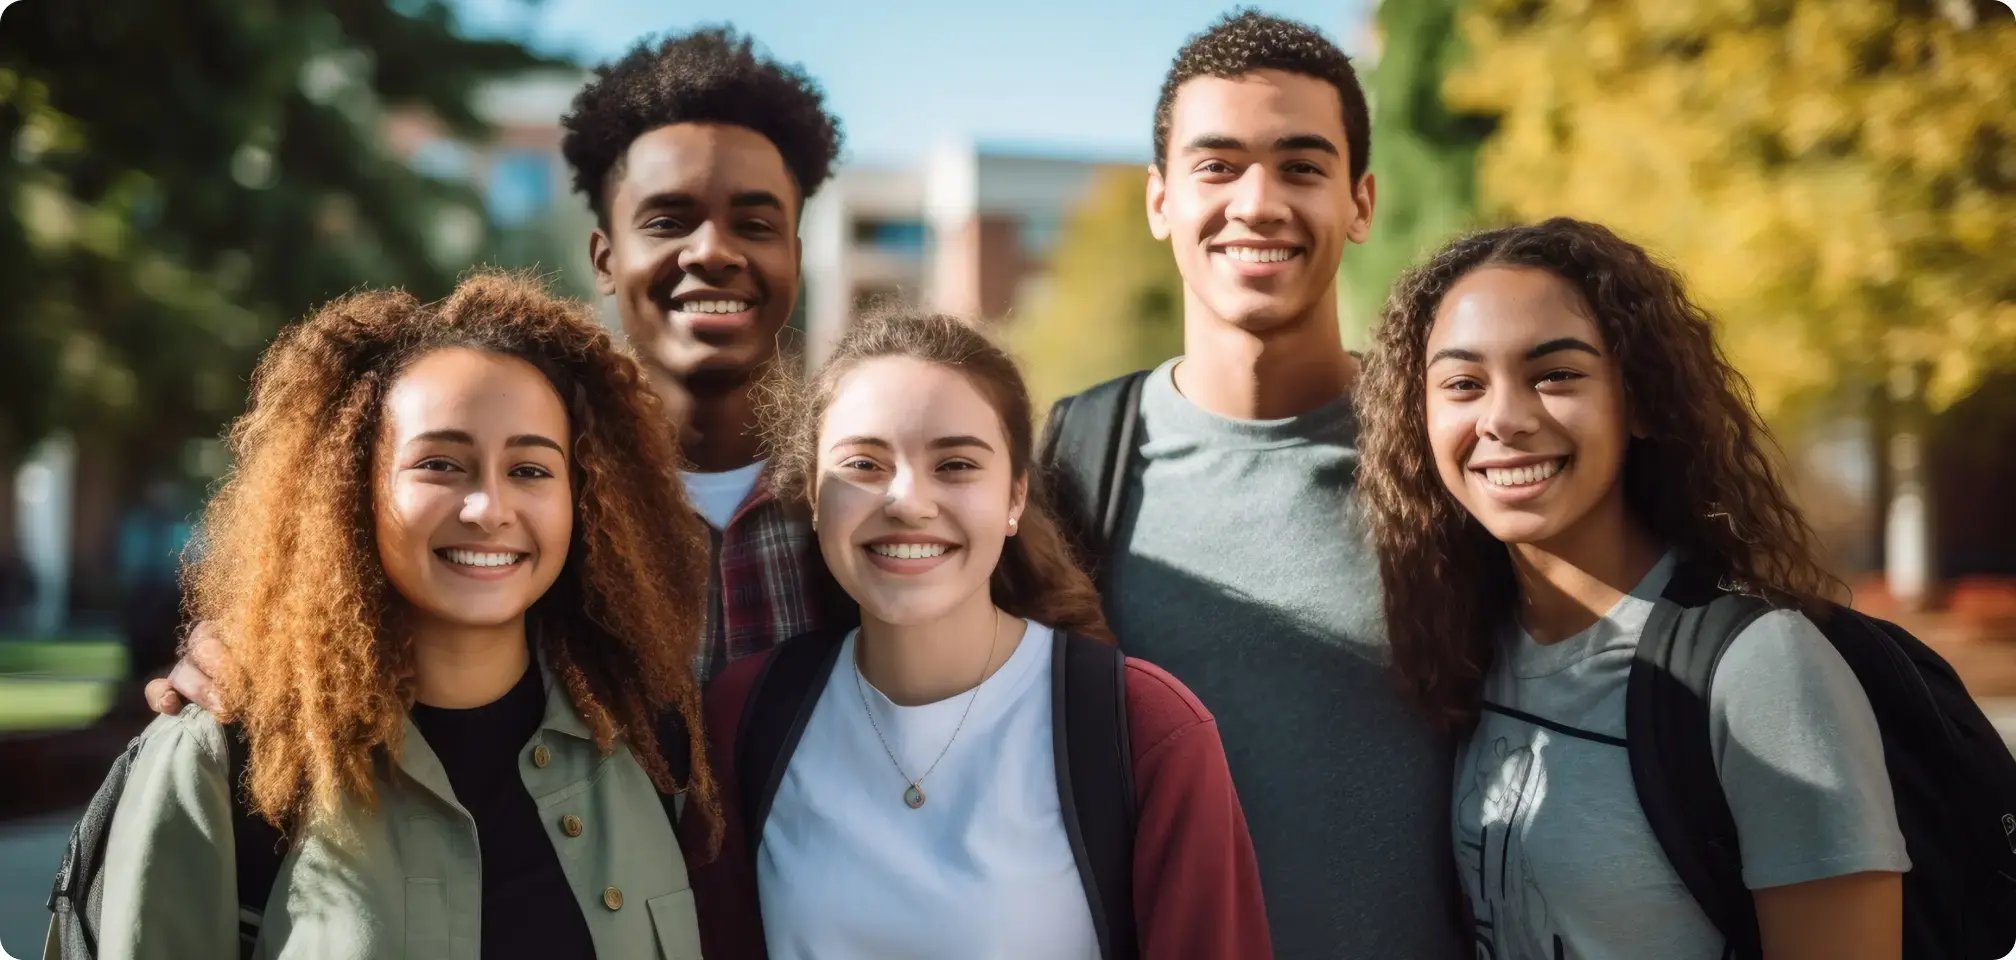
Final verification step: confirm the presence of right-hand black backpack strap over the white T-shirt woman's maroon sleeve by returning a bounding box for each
[1050,631,1141,960]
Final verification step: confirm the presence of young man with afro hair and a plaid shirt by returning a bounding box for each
[560,28,853,676]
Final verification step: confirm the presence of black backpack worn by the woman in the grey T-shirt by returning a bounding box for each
[1625,565,2016,960]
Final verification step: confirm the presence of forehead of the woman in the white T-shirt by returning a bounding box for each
[821,357,1006,450]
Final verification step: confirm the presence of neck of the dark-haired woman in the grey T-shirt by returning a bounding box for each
[1508,492,1665,643]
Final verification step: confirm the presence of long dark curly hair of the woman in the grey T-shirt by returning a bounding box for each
[1357,218,1839,728]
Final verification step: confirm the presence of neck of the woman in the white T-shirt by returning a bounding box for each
[855,591,1024,706]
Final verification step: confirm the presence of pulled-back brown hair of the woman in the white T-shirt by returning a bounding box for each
[760,307,1113,643]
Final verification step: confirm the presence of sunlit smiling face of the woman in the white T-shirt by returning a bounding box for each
[814,357,1028,625]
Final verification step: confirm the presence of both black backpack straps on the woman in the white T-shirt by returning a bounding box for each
[736,629,1139,960]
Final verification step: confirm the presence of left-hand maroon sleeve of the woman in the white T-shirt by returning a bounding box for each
[679,651,770,960]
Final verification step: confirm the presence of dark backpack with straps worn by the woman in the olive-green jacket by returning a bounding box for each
[44,710,691,960]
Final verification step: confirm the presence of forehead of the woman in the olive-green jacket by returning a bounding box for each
[385,347,566,440]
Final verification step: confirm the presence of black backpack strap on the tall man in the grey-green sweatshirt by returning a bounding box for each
[1042,371,1149,583]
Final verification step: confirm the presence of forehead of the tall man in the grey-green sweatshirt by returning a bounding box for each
[1169,69,1345,151]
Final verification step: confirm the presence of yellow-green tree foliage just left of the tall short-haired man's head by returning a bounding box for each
[1008,167,1183,409]
